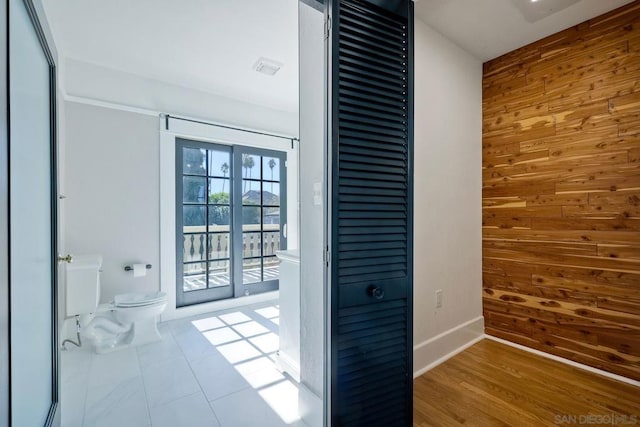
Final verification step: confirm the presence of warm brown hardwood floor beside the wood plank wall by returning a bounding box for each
[413,339,640,427]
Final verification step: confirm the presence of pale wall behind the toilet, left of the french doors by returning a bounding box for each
[63,102,160,302]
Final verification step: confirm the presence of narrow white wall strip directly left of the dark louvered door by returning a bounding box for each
[298,3,326,414]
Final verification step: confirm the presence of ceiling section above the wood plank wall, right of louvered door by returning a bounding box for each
[415,0,633,62]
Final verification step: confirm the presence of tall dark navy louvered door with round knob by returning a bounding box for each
[329,0,413,426]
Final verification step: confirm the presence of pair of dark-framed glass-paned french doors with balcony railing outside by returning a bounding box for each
[176,138,287,306]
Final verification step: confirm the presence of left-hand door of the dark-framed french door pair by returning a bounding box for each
[176,139,233,306]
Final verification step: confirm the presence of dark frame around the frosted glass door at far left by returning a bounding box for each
[0,0,60,426]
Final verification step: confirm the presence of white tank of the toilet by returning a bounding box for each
[66,255,102,316]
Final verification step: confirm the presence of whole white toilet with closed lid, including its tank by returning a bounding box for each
[66,255,167,353]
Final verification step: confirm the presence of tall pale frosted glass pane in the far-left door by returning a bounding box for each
[9,0,57,426]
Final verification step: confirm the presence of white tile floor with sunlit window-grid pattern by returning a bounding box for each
[61,303,304,427]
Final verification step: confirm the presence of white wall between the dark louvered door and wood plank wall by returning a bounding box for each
[414,20,483,372]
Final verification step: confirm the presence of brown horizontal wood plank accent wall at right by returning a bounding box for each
[482,1,640,380]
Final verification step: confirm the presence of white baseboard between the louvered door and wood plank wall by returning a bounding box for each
[413,316,484,378]
